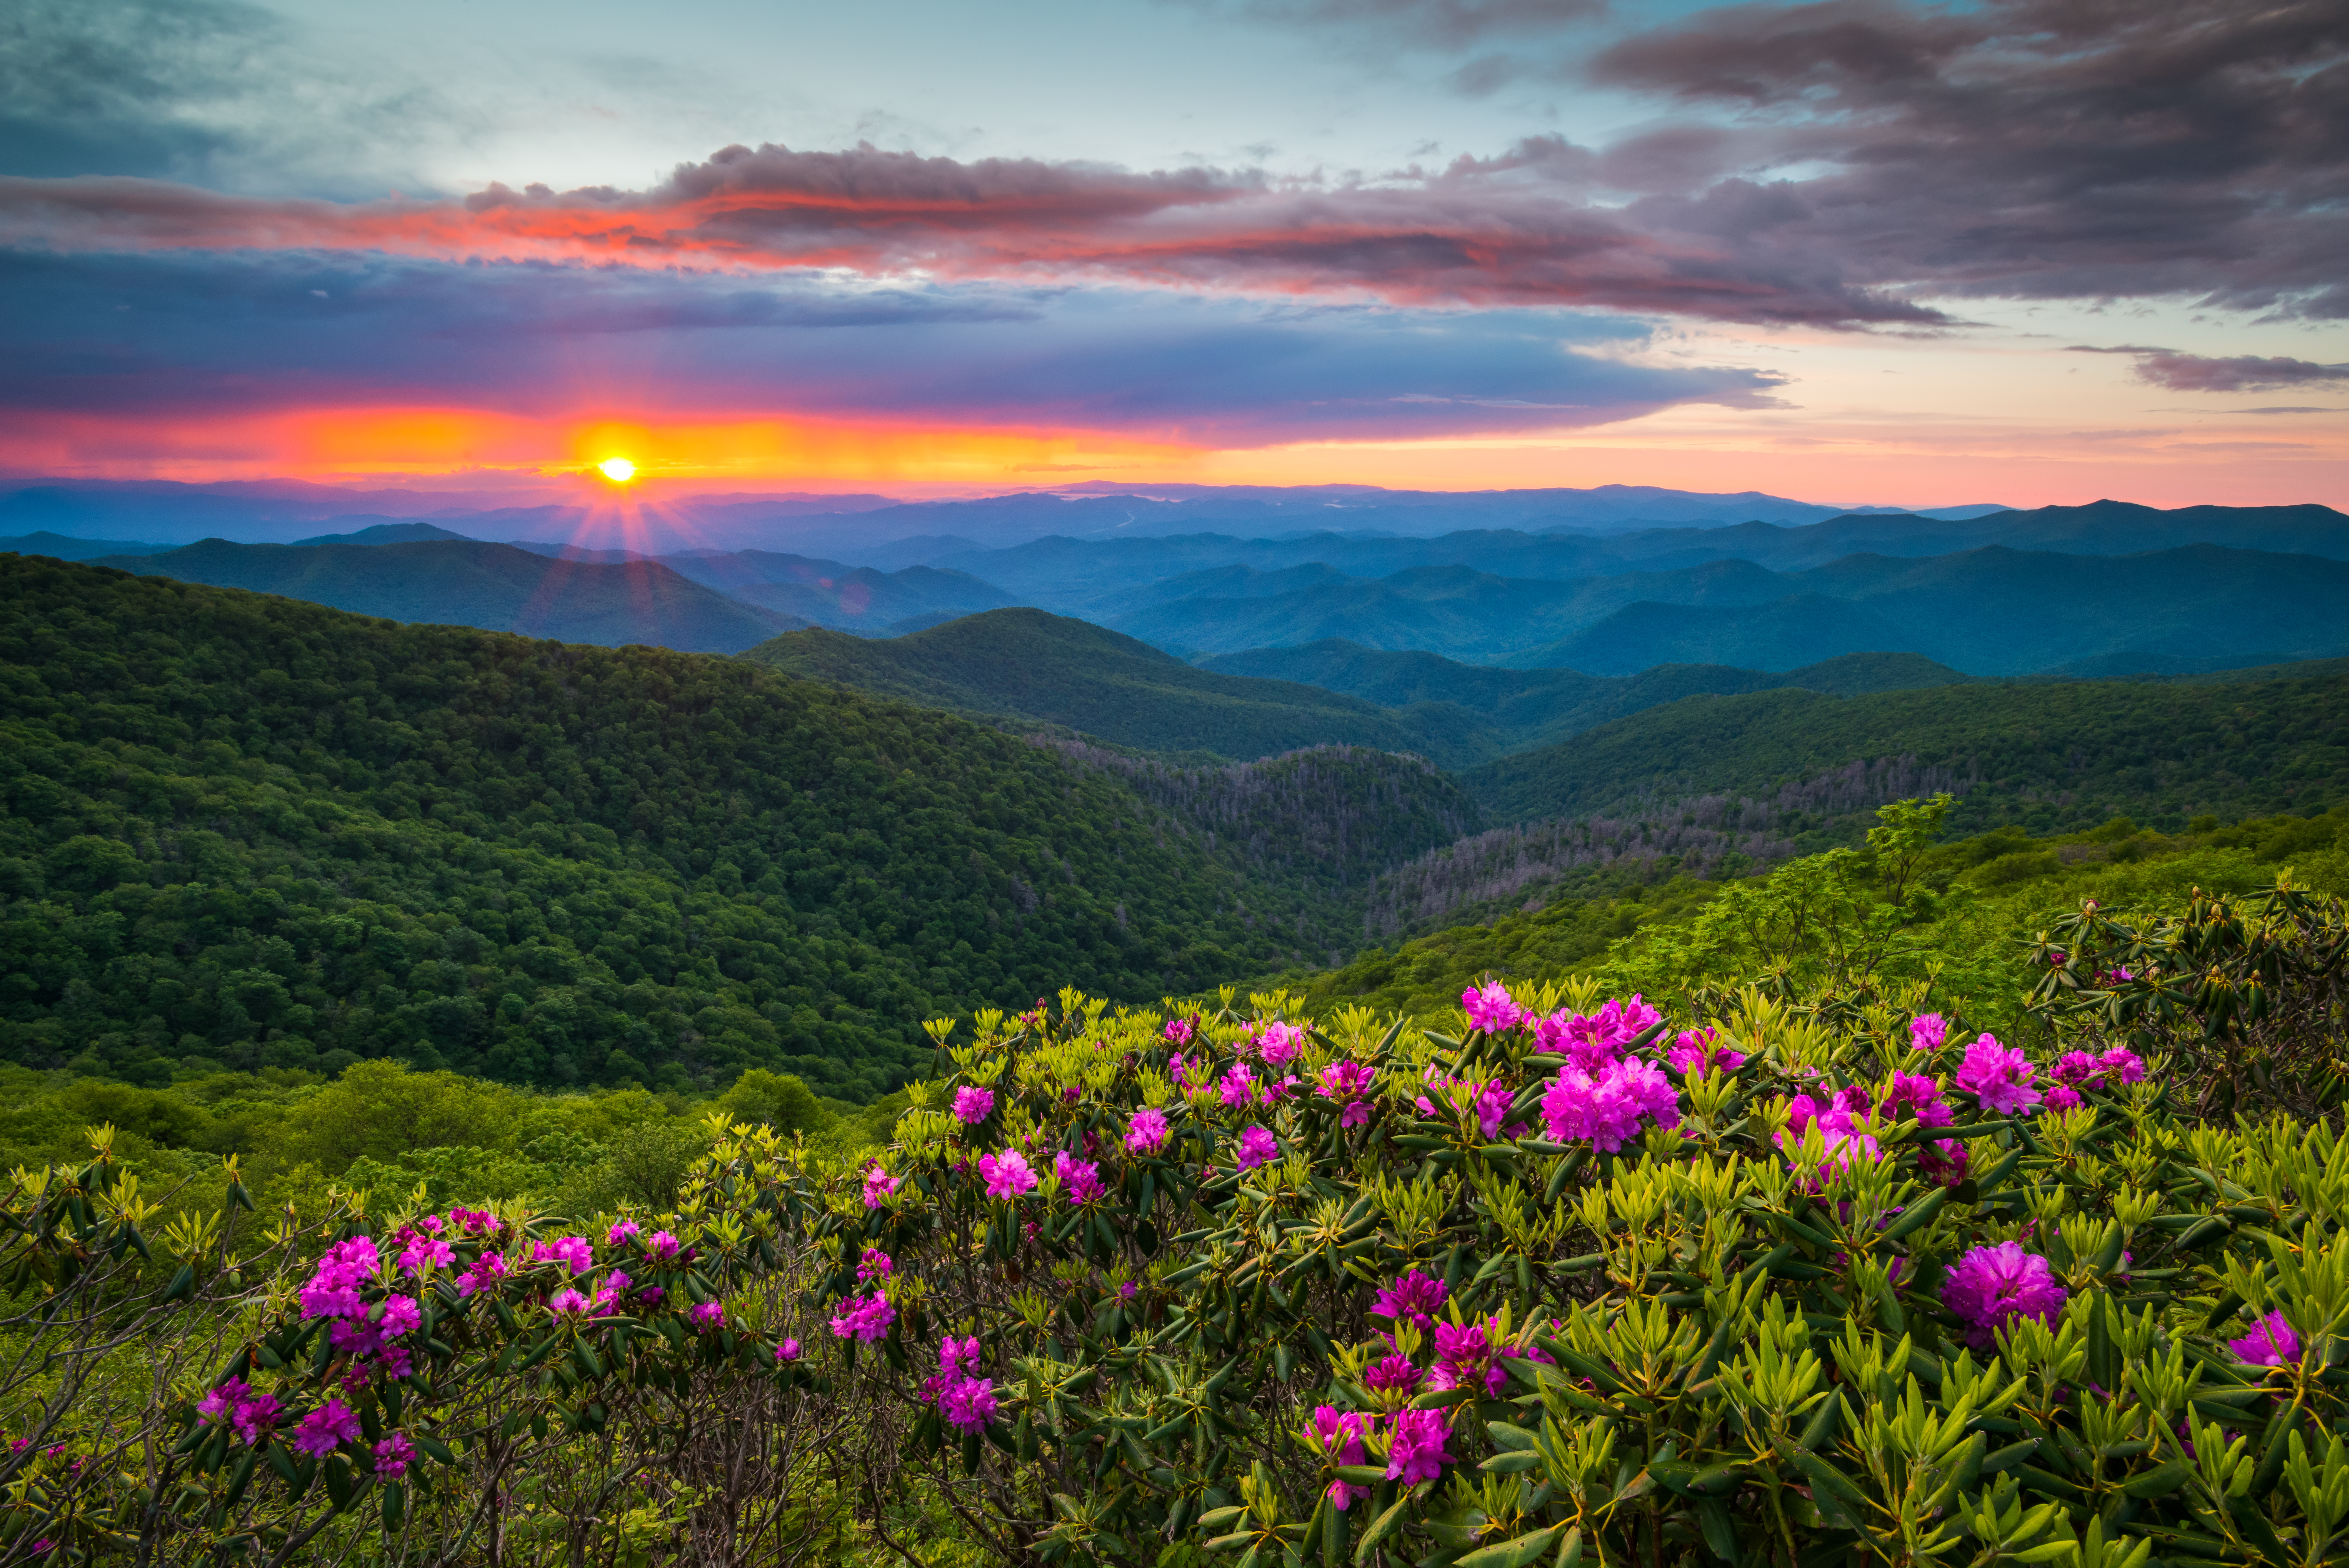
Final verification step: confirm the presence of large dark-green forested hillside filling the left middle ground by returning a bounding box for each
[0,547,1461,1096]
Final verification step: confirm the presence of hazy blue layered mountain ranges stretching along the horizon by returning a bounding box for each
[0,486,2349,699]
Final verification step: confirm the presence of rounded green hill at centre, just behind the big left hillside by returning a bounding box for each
[742,610,1499,763]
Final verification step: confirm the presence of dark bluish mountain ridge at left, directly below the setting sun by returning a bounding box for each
[103,540,806,653]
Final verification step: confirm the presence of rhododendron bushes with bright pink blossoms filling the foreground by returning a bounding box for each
[14,944,2349,1568]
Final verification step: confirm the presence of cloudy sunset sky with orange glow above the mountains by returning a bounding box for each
[0,0,2349,507]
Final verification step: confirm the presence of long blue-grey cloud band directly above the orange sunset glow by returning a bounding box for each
[0,253,1781,446]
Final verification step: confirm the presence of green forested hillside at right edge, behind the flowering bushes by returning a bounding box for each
[1464,674,2349,833]
